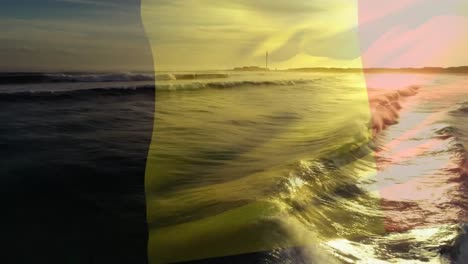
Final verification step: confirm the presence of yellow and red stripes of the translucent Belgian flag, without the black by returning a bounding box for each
[142,0,467,263]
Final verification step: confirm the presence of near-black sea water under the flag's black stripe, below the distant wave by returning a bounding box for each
[0,79,154,263]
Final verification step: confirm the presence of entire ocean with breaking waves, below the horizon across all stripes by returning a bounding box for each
[0,71,468,263]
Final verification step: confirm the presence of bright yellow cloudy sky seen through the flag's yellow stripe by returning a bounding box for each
[142,0,356,68]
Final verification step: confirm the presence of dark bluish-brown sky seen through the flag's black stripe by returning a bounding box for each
[0,0,153,72]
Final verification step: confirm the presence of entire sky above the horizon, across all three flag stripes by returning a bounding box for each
[0,0,468,71]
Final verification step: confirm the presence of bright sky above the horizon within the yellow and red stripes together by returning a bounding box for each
[142,0,468,69]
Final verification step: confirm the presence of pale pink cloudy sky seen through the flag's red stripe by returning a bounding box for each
[359,0,468,67]
